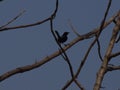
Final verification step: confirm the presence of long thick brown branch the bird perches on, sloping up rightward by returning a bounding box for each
[0,12,119,81]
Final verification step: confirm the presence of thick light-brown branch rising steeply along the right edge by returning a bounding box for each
[94,11,120,90]
